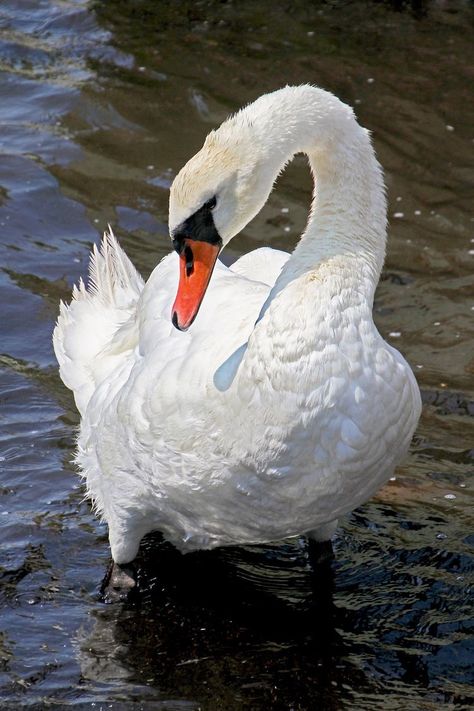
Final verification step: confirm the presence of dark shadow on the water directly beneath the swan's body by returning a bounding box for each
[78,536,344,709]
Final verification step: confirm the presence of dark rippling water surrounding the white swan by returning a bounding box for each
[0,0,474,711]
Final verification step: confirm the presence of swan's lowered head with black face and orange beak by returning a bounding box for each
[169,111,274,331]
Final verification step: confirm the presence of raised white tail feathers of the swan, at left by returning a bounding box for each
[53,227,144,414]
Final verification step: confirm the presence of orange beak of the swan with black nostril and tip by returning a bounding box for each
[171,238,220,331]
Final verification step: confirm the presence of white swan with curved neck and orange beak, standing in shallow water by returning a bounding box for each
[54,86,420,564]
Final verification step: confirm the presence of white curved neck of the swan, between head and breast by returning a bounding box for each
[253,86,386,299]
